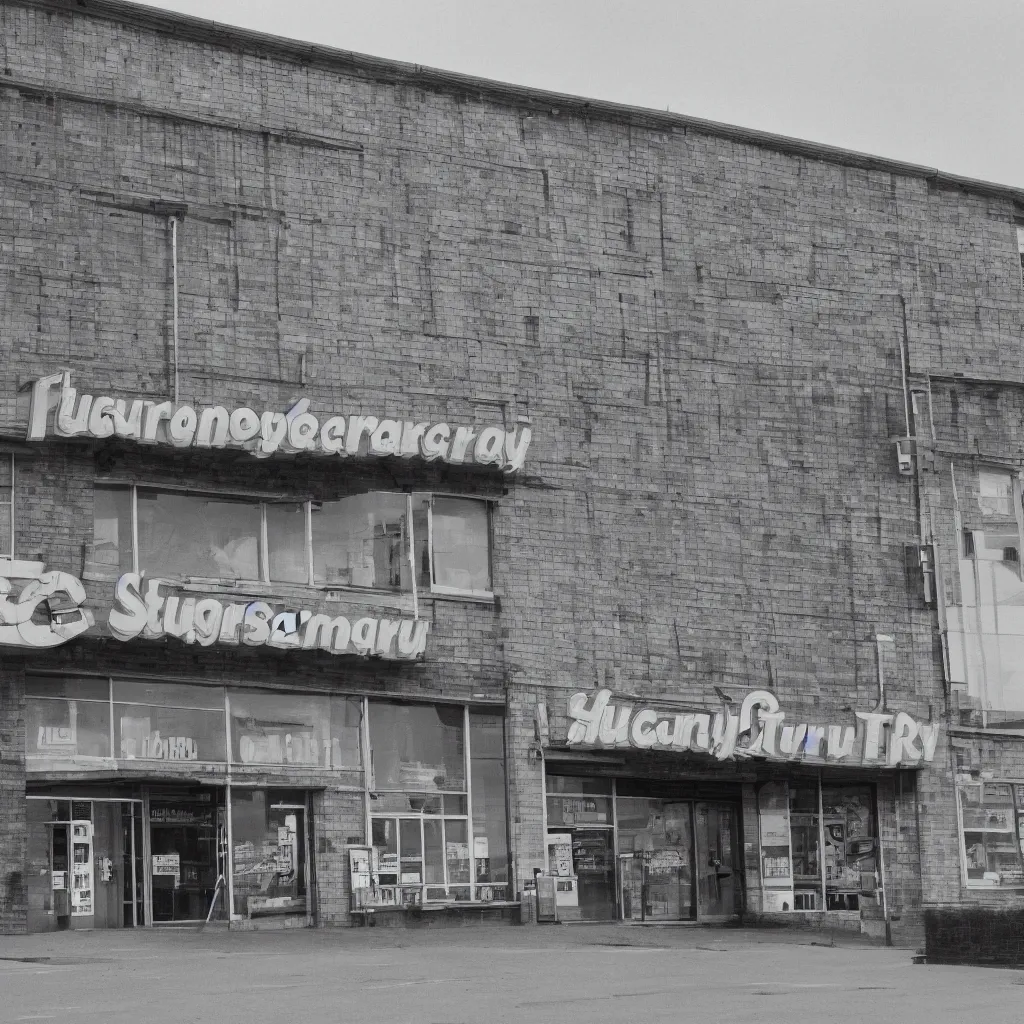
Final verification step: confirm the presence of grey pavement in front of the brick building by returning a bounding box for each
[0,925,1024,1024]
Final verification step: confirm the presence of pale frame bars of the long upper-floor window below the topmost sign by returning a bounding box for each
[94,481,495,602]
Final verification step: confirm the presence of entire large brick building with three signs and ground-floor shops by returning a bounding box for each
[0,0,1024,938]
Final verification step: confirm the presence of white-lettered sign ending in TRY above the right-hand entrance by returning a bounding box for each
[567,690,939,768]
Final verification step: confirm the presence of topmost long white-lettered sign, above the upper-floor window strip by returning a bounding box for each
[28,370,531,473]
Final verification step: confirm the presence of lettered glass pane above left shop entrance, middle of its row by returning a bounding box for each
[114,703,225,762]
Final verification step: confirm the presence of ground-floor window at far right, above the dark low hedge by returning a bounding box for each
[958,782,1024,888]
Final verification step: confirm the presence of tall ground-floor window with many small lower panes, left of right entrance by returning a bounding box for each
[369,700,509,903]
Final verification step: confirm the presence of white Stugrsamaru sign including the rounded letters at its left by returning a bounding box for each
[0,561,430,659]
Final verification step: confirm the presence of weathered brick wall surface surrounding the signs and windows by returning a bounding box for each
[0,0,1024,938]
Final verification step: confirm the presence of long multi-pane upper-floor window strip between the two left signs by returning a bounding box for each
[94,484,492,597]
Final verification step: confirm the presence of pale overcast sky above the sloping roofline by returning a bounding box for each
[151,0,1024,187]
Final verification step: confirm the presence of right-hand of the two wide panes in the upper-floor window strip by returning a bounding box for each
[311,492,411,590]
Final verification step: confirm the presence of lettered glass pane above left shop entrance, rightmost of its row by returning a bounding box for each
[230,690,331,768]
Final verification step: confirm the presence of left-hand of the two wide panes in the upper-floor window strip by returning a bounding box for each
[138,490,260,580]
